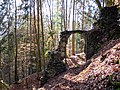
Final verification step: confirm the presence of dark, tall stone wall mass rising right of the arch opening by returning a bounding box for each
[86,6,120,59]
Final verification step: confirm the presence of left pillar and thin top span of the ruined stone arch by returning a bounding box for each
[41,30,87,85]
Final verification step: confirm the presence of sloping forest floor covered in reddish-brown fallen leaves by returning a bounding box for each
[10,39,120,90]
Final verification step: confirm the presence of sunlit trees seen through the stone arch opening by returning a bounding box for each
[66,33,85,57]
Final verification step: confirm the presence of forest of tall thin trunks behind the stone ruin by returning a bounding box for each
[0,0,119,86]
